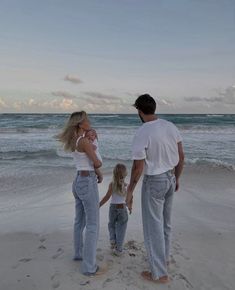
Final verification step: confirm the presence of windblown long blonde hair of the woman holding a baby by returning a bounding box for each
[56,111,87,151]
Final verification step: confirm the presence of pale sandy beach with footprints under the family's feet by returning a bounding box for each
[0,167,235,290]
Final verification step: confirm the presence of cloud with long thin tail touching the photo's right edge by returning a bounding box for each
[184,85,235,105]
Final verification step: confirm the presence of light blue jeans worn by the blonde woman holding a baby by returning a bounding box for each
[73,171,99,274]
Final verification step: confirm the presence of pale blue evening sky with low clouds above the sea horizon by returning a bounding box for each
[0,0,235,114]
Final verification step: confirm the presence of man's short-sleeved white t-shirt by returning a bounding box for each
[132,119,182,175]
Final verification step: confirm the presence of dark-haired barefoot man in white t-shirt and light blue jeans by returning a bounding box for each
[126,94,184,283]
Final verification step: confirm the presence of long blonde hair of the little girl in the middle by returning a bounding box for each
[112,163,127,196]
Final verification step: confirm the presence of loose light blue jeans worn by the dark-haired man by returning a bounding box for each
[141,171,176,279]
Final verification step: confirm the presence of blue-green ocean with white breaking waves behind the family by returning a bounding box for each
[0,114,235,176]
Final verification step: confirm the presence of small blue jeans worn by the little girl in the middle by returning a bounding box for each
[108,204,128,252]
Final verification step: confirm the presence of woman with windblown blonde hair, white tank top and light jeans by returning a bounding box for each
[57,111,102,276]
